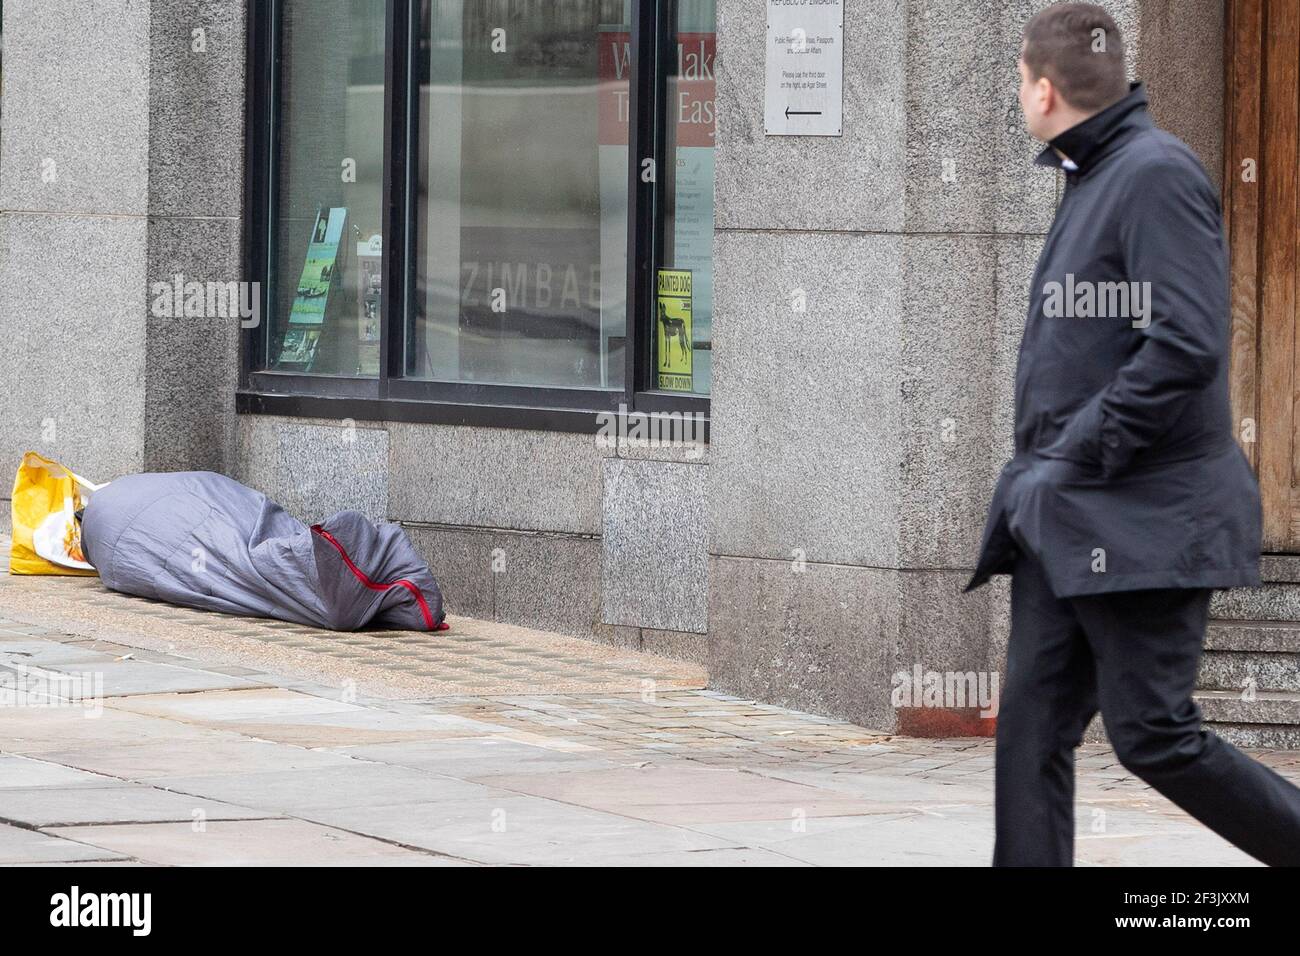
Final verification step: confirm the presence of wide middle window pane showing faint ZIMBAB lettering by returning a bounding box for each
[407,0,631,389]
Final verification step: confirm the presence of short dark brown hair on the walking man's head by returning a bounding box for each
[1021,4,1128,113]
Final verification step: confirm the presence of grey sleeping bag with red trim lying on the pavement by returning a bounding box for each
[82,471,446,631]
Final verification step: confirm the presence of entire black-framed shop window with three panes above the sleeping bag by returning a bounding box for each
[239,0,715,429]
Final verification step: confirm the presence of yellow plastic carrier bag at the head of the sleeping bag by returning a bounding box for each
[9,451,103,575]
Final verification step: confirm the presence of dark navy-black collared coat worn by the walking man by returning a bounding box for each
[967,85,1260,597]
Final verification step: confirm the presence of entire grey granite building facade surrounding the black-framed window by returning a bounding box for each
[0,0,1242,732]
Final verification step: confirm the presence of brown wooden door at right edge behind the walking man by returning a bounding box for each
[1223,0,1300,553]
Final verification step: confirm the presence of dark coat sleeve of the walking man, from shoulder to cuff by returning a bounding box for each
[1040,155,1227,477]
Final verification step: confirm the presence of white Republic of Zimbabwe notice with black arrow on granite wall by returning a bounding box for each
[763,0,844,137]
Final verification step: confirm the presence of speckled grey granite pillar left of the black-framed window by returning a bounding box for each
[0,0,244,480]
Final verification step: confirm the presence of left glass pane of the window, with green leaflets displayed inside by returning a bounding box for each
[260,0,385,377]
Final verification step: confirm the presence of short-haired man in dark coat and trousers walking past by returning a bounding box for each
[967,3,1300,866]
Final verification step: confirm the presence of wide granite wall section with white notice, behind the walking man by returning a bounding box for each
[709,0,1222,734]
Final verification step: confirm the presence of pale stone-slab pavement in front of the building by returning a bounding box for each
[0,561,1300,866]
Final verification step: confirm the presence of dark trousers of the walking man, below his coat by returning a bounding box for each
[993,555,1300,866]
